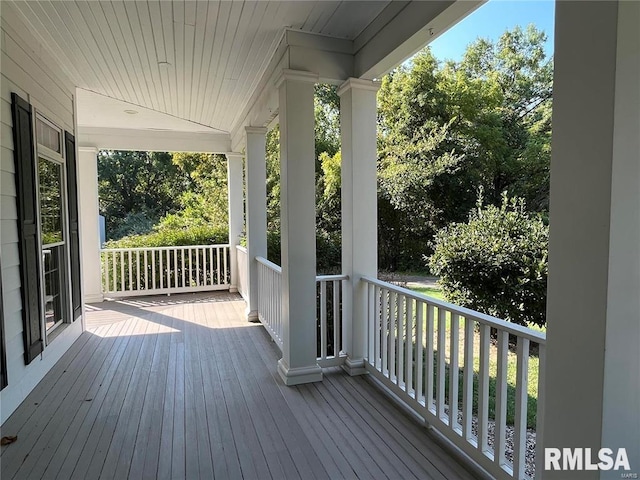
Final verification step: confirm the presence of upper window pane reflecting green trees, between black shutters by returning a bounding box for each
[38,158,63,245]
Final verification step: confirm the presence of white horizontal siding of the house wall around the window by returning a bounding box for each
[0,4,82,423]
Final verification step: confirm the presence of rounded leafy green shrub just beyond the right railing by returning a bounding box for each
[429,194,549,326]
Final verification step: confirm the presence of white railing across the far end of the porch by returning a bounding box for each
[101,245,230,297]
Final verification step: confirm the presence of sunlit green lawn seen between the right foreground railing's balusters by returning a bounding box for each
[411,287,544,429]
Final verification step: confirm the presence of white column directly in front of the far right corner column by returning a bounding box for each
[245,127,267,322]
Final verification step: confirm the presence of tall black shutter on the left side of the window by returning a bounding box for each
[11,93,44,364]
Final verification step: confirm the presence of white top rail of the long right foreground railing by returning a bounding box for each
[362,277,547,345]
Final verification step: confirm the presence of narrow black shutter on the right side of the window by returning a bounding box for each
[64,132,82,321]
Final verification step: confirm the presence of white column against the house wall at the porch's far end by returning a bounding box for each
[78,147,103,303]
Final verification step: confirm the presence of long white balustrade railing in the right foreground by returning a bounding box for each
[363,278,546,479]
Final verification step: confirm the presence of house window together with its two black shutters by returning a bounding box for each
[10,92,82,366]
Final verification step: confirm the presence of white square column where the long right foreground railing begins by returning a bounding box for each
[338,78,379,375]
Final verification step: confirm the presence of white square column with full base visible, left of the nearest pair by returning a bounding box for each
[276,70,322,385]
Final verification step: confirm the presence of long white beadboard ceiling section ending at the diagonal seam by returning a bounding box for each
[13,0,389,131]
